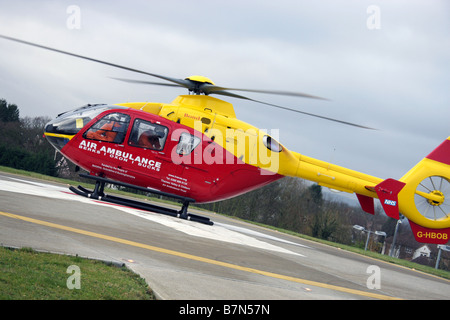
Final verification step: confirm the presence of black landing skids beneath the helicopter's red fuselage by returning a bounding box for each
[69,174,214,225]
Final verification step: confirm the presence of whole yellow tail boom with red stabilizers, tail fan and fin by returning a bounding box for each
[283,137,450,244]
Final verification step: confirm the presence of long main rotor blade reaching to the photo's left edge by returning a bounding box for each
[0,34,191,88]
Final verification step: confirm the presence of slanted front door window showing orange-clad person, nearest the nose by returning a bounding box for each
[83,112,130,143]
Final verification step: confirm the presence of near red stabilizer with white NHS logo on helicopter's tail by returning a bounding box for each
[375,179,405,220]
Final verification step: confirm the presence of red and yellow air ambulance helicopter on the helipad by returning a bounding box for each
[0,35,450,244]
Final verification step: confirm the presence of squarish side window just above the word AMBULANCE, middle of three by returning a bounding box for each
[128,119,169,151]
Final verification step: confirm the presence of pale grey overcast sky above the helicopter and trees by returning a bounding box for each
[0,0,450,202]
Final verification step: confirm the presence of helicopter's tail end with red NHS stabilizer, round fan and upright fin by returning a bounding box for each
[358,137,450,244]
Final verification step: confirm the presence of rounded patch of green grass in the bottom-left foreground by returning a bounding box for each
[0,247,155,300]
